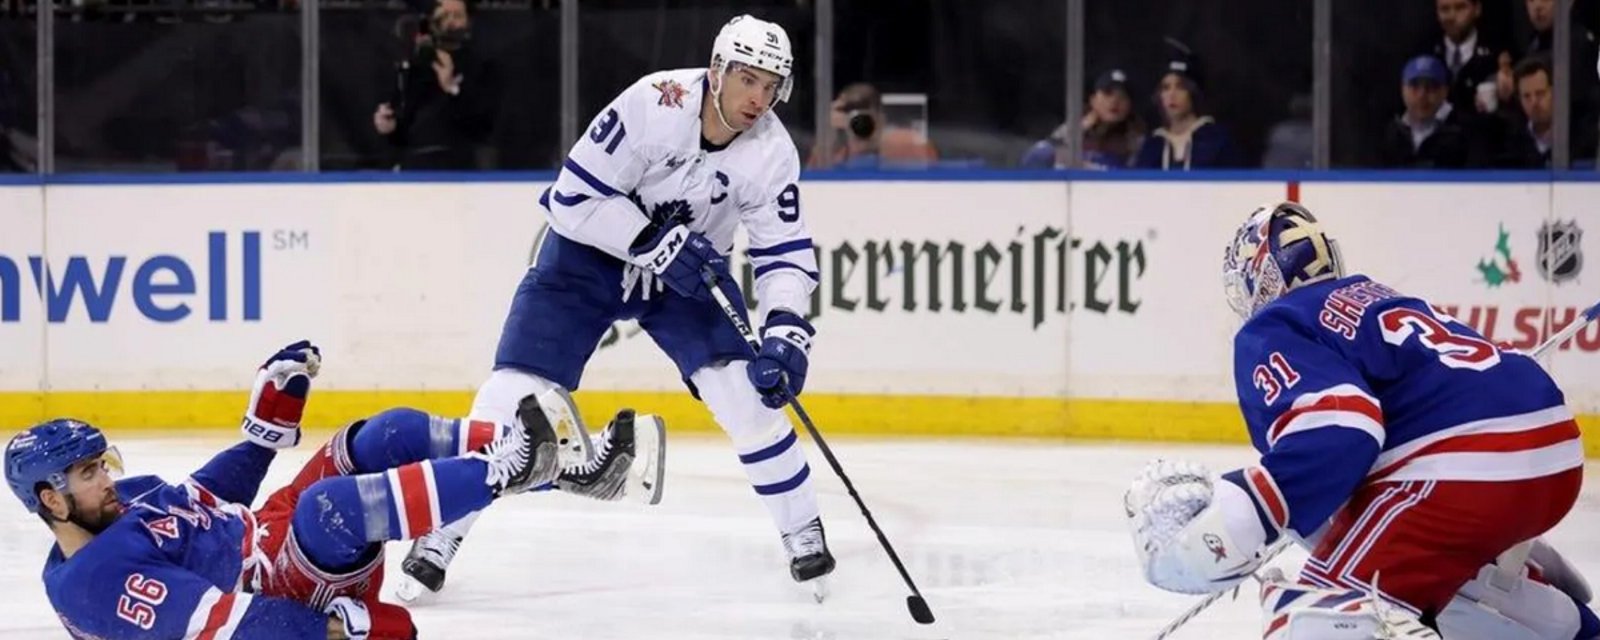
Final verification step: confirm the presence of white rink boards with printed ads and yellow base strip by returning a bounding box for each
[0,179,1600,454]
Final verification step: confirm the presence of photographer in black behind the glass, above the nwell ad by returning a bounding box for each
[373,0,501,171]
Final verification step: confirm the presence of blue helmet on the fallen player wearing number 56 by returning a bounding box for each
[5,418,122,512]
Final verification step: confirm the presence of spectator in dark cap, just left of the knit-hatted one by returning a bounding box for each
[1022,69,1147,170]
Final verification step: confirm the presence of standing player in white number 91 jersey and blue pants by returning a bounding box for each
[400,16,834,598]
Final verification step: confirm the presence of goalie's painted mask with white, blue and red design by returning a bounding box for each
[1222,202,1344,320]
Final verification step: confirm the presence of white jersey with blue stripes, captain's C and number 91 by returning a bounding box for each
[539,69,818,318]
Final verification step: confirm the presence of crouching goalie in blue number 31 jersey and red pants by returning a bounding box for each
[1126,202,1600,640]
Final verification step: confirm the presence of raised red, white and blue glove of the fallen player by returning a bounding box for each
[238,341,322,450]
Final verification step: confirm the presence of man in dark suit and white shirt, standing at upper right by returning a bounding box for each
[1421,0,1512,115]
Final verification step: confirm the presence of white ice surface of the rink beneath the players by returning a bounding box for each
[0,437,1600,640]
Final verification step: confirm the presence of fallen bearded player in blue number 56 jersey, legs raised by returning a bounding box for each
[5,342,659,640]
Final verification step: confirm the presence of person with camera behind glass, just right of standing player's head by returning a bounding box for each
[806,82,939,170]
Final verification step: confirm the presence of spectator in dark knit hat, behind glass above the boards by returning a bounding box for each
[1134,52,1242,171]
